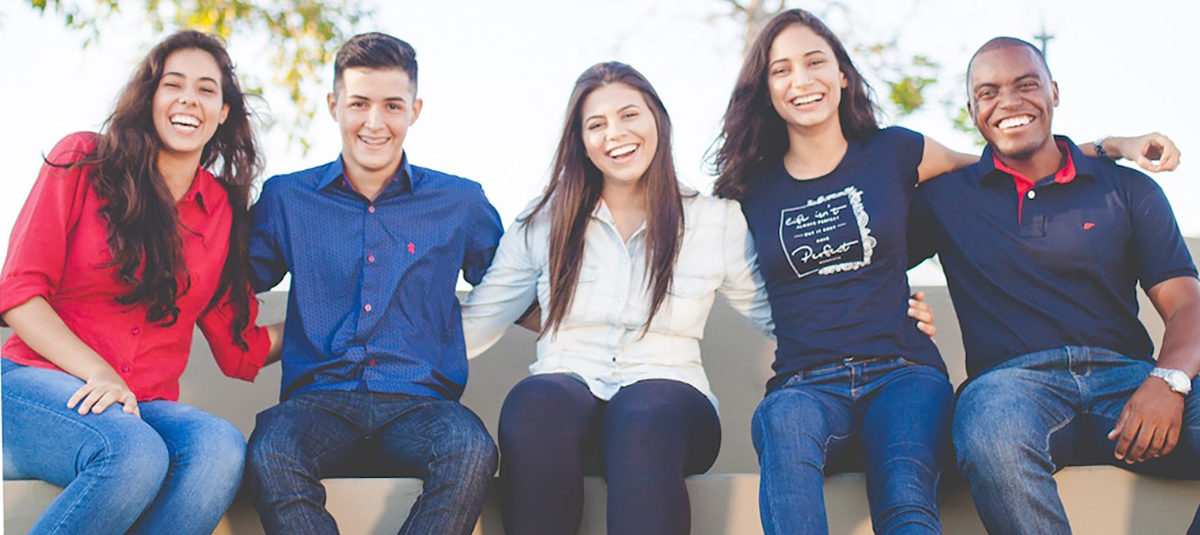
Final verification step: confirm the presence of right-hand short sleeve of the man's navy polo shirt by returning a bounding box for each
[1127,169,1196,291]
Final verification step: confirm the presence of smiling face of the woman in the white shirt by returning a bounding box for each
[580,83,659,185]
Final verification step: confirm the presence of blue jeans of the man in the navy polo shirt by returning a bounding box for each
[954,347,1200,534]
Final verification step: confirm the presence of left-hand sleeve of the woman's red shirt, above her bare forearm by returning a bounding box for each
[0,132,96,326]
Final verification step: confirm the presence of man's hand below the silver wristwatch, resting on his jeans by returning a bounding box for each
[1109,377,1183,464]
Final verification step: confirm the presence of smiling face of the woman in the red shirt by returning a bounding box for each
[151,48,229,160]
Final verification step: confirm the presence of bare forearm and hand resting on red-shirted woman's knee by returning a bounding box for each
[2,296,142,416]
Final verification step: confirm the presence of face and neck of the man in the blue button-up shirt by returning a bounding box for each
[328,67,421,181]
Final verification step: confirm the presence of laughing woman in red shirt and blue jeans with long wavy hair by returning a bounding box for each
[0,31,280,534]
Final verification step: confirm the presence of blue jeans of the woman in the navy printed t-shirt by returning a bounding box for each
[751,359,954,535]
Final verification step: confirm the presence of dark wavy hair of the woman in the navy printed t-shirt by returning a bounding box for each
[709,10,880,199]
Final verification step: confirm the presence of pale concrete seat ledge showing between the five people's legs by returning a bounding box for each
[4,467,1200,535]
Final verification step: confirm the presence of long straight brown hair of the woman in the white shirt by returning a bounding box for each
[524,61,683,336]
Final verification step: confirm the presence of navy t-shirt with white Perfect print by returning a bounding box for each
[742,127,946,391]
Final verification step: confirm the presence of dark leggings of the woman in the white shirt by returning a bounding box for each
[500,374,721,535]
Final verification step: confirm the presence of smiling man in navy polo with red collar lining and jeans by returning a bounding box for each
[908,37,1200,534]
